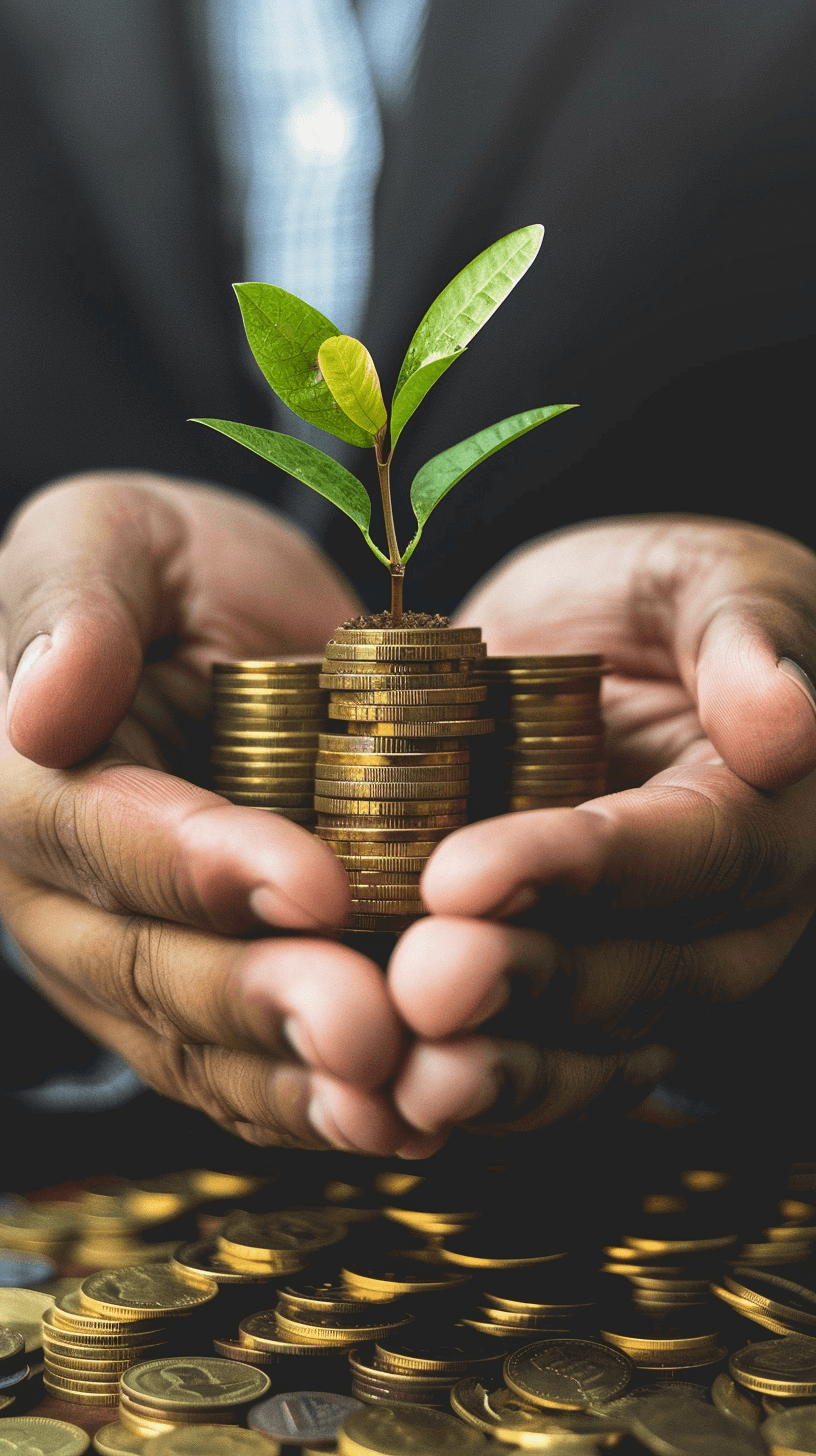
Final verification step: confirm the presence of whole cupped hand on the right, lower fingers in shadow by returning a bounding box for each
[389,517,816,1133]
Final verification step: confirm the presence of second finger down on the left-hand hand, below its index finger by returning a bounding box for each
[0,869,402,1089]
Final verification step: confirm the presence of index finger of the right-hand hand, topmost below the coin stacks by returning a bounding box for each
[423,763,798,914]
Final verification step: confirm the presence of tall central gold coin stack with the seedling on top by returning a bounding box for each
[315,628,493,932]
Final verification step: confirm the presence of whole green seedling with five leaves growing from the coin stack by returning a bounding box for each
[194,223,576,626]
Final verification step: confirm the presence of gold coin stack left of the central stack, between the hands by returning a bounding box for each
[211,658,328,824]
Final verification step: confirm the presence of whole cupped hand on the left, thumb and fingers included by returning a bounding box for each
[0,473,439,1156]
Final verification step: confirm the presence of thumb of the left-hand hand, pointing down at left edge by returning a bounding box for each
[0,476,174,767]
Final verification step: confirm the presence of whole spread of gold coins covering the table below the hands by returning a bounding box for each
[0,1165,816,1456]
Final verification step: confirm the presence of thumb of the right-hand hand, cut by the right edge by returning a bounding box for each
[697,596,816,789]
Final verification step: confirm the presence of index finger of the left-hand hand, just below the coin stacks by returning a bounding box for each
[0,757,350,933]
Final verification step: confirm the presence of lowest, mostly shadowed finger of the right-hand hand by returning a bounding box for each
[393,1037,675,1134]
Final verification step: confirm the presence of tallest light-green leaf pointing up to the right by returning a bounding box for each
[393,223,544,422]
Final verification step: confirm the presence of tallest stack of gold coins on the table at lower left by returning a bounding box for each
[42,1293,169,1405]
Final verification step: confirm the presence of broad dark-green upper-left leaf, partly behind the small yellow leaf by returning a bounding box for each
[235,282,372,446]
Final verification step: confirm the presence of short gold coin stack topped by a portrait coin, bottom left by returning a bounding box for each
[119,1354,270,1437]
